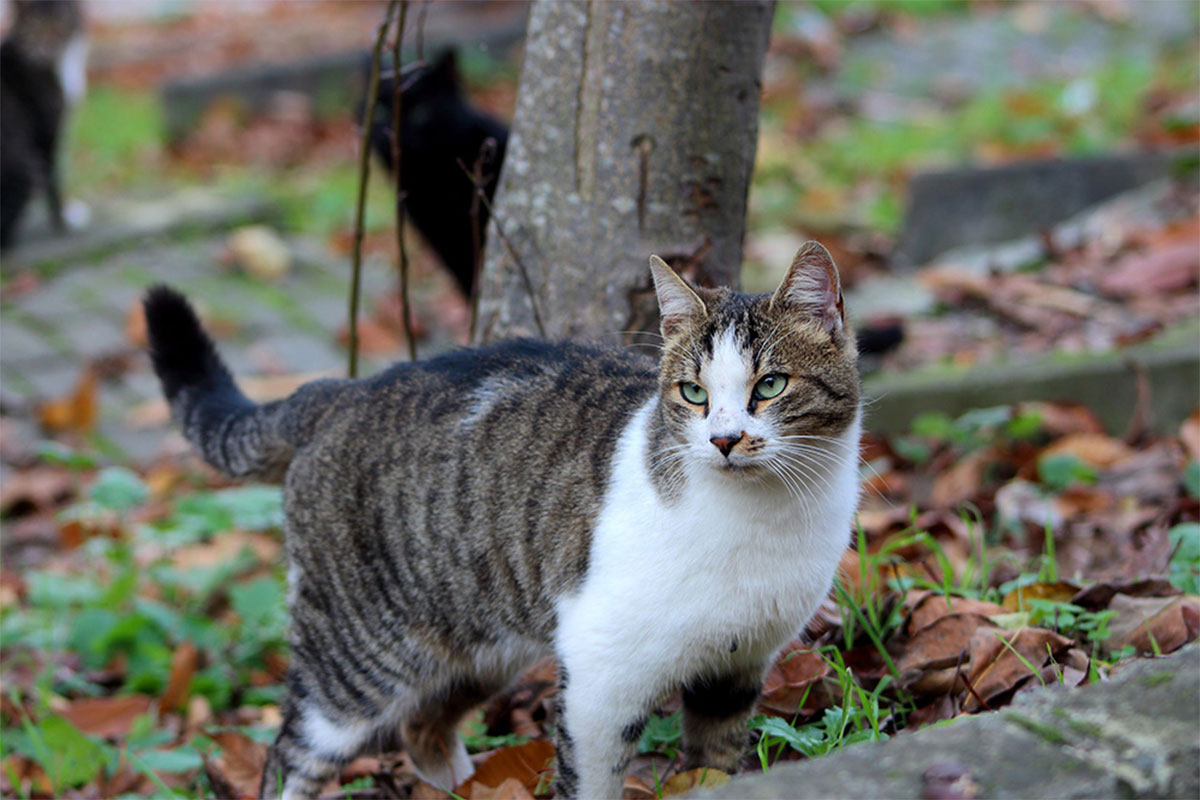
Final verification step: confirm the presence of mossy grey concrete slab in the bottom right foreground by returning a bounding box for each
[689,644,1200,800]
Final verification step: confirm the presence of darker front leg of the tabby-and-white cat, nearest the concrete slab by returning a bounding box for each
[683,668,764,774]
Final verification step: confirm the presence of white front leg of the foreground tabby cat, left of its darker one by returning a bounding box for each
[554,660,650,800]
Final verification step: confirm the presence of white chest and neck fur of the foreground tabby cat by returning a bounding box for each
[558,402,859,694]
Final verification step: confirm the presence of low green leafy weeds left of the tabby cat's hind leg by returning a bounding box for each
[0,453,287,796]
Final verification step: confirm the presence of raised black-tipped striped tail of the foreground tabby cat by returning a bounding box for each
[143,285,295,481]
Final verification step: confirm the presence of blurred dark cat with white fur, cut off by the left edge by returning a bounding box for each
[0,0,88,247]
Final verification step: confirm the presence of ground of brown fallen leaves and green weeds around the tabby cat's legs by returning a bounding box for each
[0,404,1200,800]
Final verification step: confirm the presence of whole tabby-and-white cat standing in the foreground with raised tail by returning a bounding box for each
[145,242,862,798]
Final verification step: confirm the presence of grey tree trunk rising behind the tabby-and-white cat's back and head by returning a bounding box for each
[476,0,774,342]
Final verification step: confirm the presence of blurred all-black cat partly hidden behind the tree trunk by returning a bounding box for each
[371,50,509,297]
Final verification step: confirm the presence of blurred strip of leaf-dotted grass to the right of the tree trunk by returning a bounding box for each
[751,47,1198,233]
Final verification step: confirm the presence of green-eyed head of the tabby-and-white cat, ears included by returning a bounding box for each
[653,242,859,479]
